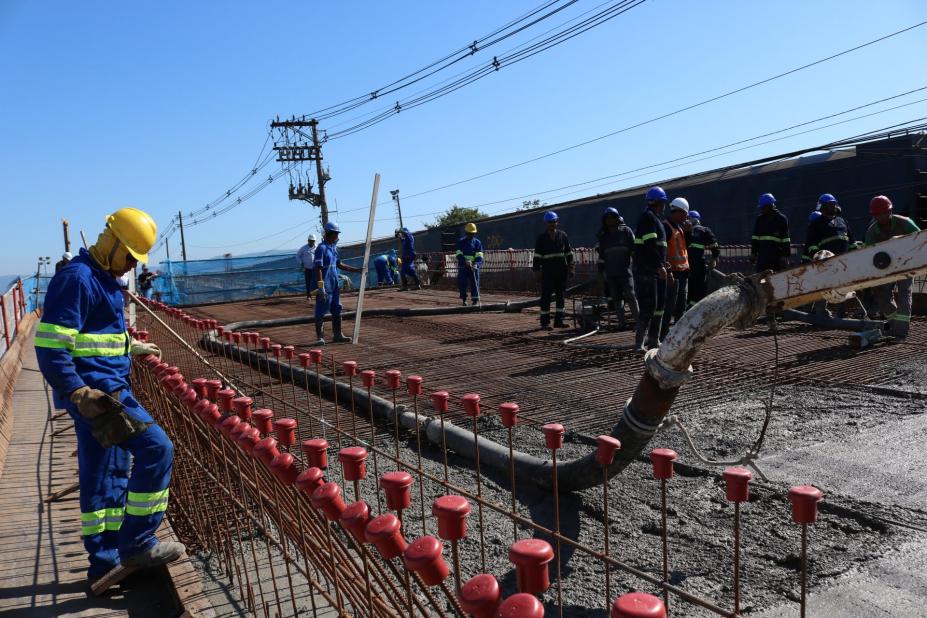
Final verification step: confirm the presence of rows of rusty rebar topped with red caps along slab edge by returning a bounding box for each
[133,303,822,617]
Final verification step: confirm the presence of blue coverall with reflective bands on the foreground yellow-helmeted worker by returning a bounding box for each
[35,249,174,577]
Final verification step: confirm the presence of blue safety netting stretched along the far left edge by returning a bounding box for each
[152,253,388,305]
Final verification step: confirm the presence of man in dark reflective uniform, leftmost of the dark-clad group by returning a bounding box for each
[531,210,575,330]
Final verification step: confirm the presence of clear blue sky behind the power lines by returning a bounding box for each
[0,0,927,274]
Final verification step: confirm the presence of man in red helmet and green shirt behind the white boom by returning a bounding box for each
[865,195,920,339]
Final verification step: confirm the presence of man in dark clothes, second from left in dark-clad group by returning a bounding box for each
[596,207,638,328]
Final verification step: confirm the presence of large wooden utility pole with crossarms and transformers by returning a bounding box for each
[270,117,331,226]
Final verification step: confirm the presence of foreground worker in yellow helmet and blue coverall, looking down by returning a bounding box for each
[35,208,185,583]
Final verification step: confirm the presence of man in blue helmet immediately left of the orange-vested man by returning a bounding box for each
[634,187,670,352]
